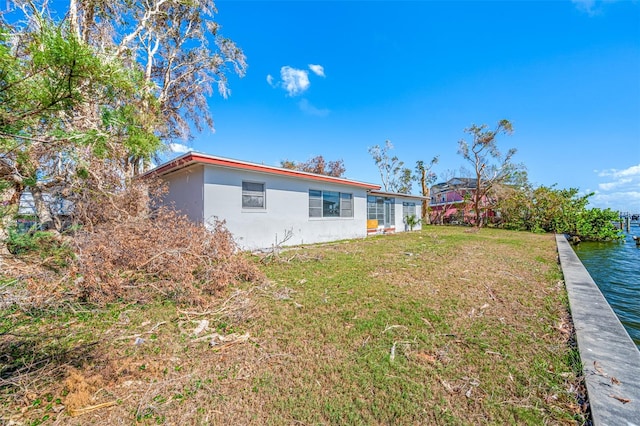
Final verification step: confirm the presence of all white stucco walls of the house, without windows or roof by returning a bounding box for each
[158,164,421,250]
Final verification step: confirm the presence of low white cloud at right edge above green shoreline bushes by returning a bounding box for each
[591,164,640,213]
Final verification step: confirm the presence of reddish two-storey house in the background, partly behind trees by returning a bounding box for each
[429,177,495,223]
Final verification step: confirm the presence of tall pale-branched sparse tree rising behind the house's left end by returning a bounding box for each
[67,0,247,175]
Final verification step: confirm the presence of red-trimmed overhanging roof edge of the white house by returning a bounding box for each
[144,152,380,190]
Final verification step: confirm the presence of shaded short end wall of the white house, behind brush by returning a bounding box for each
[162,166,204,223]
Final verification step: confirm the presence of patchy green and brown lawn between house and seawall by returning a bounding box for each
[0,227,586,425]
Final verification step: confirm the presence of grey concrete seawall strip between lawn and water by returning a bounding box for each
[556,235,640,426]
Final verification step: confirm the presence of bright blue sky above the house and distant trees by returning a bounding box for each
[165,0,640,212]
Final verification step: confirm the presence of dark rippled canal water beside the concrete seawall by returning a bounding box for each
[574,222,640,349]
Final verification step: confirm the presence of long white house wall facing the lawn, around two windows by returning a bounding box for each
[203,166,367,250]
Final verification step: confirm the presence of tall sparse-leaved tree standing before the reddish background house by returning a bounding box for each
[458,120,520,227]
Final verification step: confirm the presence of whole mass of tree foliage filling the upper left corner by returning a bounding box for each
[0,0,246,240]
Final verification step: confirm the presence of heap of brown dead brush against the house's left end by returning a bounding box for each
[8,173,262,305]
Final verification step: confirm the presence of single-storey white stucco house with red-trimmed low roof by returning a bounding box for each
[147,152,423,250]
